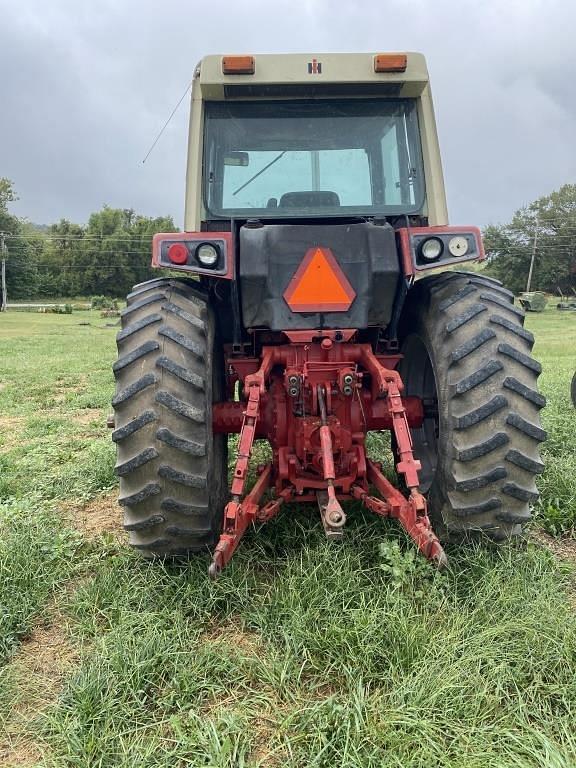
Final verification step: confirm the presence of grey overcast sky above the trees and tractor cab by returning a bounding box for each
[0,0,576,226]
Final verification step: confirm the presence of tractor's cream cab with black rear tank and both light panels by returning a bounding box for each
[156,53,482,345]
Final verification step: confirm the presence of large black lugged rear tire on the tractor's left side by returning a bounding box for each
[112,278,227,557]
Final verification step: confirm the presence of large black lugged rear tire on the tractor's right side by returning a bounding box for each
[399,272,546,541]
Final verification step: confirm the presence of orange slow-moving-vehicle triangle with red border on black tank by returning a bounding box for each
[284,248,356,312]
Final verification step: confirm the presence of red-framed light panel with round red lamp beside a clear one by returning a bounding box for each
[152,232,234,280]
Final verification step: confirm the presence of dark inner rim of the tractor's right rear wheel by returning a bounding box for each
[400,335,440,493]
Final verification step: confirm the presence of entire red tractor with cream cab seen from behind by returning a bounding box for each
[112,53,546,577]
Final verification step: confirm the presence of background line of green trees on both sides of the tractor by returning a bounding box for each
[0,178,576,300]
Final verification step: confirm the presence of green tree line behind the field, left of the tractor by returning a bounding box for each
[0,178,176,301]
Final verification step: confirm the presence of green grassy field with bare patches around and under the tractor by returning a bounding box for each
[0,310,576,768]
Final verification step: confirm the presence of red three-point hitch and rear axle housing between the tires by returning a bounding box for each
[209,333,447,577]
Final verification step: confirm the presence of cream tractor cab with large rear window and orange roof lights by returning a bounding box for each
[185,53,447,231]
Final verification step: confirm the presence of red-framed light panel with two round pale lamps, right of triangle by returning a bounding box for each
[397,227,485,275]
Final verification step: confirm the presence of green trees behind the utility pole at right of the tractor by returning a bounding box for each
[484,184,576,293]
